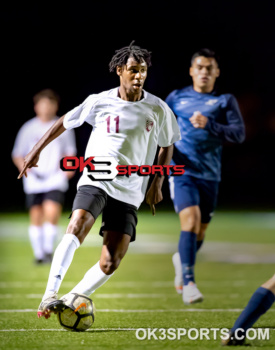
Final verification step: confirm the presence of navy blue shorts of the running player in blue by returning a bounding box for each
[169,175,219,224]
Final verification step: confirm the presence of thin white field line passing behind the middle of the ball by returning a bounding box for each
[0,309,275,313]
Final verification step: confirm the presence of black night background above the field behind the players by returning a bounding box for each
[0,1,275,211]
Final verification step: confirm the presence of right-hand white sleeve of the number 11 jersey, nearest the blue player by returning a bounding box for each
[158,101,181,147]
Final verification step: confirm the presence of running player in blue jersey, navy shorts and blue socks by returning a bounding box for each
[166,49,245,305]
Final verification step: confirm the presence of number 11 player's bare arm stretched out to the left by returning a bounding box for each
[17,116,66,179]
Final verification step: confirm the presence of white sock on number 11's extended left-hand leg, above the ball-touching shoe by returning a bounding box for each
[42,233,80,300]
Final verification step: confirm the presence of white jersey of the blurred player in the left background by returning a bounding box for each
[12,117,76,194]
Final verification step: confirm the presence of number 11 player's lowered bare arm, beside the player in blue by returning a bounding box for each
[146,145,174,215]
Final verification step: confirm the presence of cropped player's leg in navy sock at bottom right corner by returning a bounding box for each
[222,275,275,345]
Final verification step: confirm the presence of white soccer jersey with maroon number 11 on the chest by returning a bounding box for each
[64,88,180,207]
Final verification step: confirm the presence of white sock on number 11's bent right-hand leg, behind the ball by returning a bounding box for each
[70,261,113,296]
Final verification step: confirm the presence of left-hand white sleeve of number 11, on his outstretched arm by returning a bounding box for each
[63,95,97,129]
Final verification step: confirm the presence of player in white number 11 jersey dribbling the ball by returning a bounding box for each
[19,42,180,318]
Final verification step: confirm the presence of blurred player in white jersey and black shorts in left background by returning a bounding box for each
[12,89,76,264]
